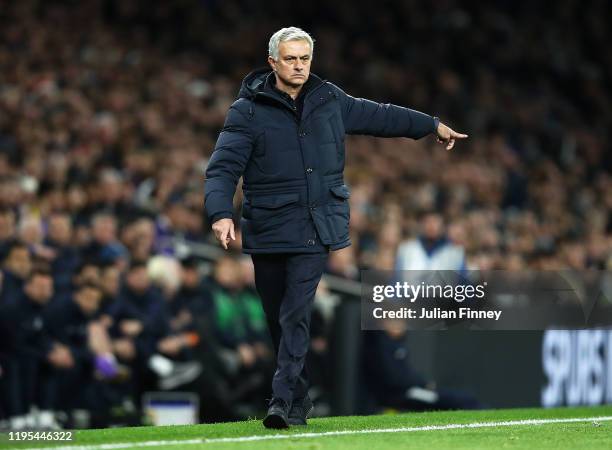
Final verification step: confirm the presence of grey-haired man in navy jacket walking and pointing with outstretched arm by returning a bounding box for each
[205,27,467,428]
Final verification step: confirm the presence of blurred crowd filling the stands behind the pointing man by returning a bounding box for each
[0,0,612,424]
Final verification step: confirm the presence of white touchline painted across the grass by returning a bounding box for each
[9,416,612,450]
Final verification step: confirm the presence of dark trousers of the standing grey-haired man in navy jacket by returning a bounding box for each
[252,252,328,404]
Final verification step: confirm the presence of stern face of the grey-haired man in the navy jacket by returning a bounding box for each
[268,40,311,88]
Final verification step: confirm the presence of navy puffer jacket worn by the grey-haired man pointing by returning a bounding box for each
[205,70,437,253]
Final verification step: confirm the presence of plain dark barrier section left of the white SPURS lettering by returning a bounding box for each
[407,330,546,408]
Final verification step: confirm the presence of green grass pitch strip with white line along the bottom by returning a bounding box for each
[0,405,612,450]
